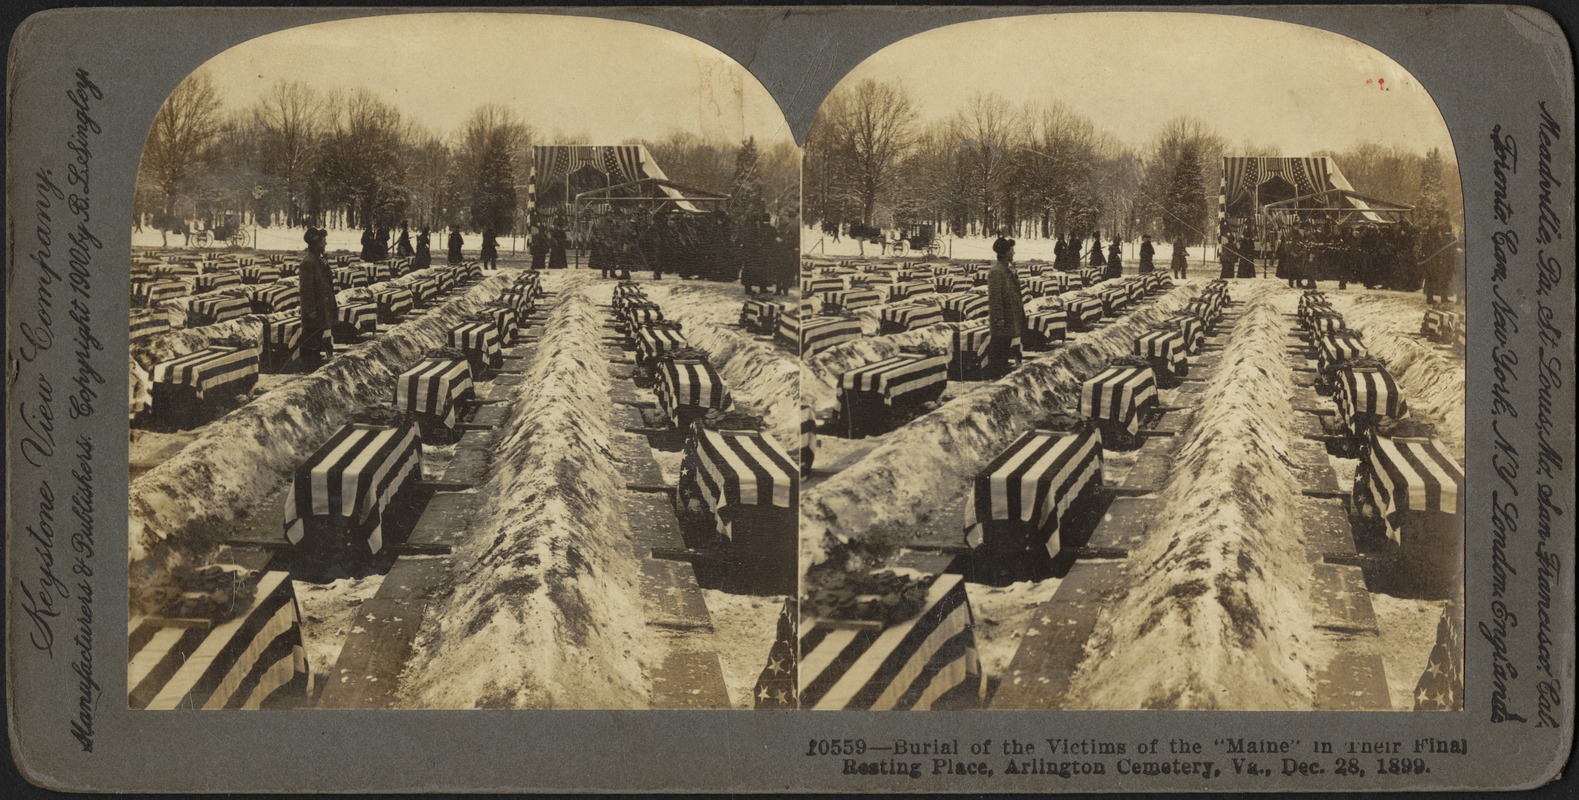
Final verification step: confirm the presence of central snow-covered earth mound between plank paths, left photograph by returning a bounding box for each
[401,273,662,708]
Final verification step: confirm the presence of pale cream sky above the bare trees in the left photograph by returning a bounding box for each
[194,13,793,144]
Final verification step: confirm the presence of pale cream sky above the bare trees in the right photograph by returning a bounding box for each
[842,11,1453,159]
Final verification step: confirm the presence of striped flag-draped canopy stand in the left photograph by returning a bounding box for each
[526,145,725,215]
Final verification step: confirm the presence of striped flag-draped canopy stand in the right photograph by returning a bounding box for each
[1217,156,1413,246]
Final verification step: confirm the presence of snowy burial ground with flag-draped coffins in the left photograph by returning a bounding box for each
[128,249,799,708]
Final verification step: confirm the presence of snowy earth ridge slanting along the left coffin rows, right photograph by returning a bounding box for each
[801,282,1200,571]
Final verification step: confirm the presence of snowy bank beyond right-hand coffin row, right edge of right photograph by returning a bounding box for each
[1320,289,1464,464]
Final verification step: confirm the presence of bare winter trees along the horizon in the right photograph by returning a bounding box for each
[804,79,1462,241]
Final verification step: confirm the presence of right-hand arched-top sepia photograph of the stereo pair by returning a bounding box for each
[802,11,1465,712]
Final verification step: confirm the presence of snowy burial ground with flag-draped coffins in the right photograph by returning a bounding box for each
[797,257,1464,710]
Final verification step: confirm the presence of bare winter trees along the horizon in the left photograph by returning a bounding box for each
[134,71,799,232]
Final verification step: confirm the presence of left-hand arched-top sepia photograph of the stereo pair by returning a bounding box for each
[126,13,801,710]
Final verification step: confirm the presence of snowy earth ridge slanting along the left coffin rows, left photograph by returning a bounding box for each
[128,276,505,598]
